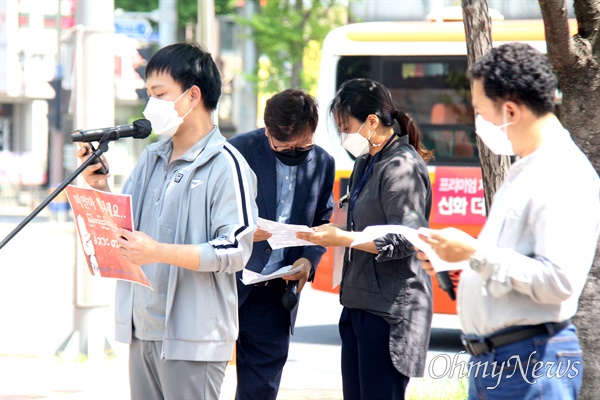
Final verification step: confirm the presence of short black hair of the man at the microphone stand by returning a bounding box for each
[146,43,221,111]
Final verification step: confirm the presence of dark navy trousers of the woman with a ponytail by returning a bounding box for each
[339,307,410,400]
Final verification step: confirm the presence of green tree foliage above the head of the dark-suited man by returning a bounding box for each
[237,0,346,93]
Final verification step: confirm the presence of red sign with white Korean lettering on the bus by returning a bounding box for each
[432,166,486,225]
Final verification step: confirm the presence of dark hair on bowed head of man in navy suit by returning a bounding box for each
[264,89,319,142]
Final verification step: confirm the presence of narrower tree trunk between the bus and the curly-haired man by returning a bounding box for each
[462,0,510,210]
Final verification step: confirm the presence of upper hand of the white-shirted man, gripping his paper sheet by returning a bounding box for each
[417,228,477,262]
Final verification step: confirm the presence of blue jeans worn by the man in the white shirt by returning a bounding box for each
[469,324,583,400]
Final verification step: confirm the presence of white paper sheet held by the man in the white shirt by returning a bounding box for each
[351,225,468,272]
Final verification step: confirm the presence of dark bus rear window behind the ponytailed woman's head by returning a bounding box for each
[336,56,479,165]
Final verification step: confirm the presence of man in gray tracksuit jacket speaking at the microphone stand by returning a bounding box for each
[79,43,258,400]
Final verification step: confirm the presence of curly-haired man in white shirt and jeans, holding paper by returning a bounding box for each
[418,43,600,399]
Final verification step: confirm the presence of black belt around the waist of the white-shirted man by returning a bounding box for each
[461,319,571,356]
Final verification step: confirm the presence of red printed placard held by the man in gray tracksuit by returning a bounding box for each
[65,185,150,287]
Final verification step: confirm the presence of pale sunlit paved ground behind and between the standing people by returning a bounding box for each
[0,204,459,400]
